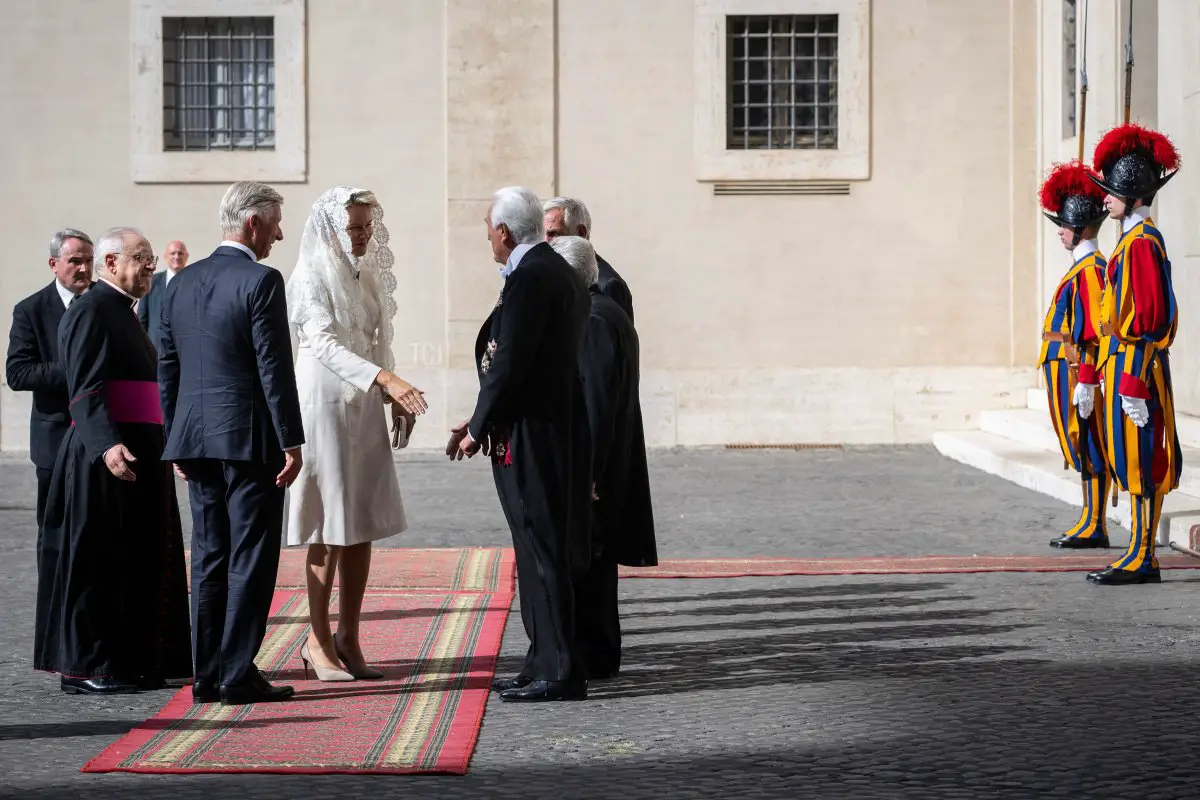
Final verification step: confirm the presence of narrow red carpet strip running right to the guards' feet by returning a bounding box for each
[620,549,1200,578]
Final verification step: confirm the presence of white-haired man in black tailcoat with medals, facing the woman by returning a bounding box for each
[446,187,592,702]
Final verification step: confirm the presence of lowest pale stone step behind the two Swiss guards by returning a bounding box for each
[934,431,1200,547]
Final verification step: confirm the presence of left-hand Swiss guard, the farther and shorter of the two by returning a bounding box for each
[1038,161,1109,548]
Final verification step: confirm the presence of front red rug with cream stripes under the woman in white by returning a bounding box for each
[82,590,512,775]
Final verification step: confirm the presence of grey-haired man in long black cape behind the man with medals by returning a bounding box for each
[550,236,658,680]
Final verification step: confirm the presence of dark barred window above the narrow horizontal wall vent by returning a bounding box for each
[726,14,838,150]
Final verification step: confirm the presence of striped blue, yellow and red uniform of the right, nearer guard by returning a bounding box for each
[1100,217,1183,571]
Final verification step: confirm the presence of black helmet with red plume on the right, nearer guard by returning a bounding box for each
[1092,125,1180,203]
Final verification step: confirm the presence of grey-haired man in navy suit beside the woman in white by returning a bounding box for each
[157,181,304,705]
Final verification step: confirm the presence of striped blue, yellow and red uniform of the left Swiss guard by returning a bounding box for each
[1038,240,1109,539]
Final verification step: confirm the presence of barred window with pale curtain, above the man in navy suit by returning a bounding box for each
[162,17,275,150]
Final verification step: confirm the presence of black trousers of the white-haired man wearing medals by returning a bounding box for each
[492,464,586,681]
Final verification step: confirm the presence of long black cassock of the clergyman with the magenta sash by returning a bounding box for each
[34,282,192,680]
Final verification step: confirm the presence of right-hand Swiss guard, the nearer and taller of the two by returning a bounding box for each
[1087,125,1183,585]
